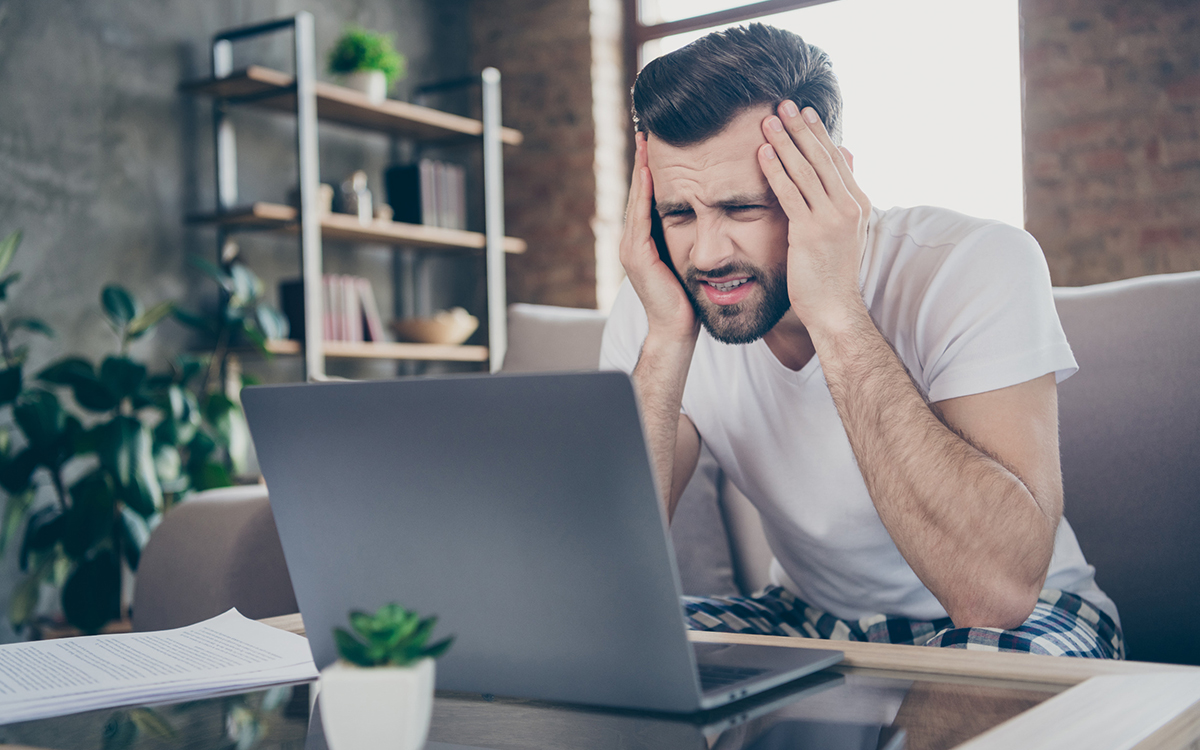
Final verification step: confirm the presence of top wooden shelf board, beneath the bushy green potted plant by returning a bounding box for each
[180,65,524,145]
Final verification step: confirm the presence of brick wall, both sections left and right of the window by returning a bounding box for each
[472,0,1200,298]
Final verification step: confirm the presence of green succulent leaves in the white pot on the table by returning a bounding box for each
[334,602,454,667]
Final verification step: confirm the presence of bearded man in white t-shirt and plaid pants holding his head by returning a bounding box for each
[601,24,1123,658]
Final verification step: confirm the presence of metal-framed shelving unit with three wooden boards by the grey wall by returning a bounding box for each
[180,12,526,380]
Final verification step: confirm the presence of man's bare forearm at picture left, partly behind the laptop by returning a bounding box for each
[632,336,696,518]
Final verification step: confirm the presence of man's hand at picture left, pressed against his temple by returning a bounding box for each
[620,133,700,341]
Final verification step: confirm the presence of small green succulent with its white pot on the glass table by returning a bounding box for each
[317,604,454,750]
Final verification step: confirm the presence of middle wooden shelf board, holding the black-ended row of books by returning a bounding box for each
[187,202,526,253]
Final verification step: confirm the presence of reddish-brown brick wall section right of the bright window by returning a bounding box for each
[1021,0,1200,286]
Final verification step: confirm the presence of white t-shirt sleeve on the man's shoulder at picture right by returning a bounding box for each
[913,223,1079,401]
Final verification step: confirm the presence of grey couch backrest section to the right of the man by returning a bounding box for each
[1055,272,1200,664]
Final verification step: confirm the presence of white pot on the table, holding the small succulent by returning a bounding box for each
[317,659,434,750]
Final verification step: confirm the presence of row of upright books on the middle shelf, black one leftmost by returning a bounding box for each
[384,158,467,229]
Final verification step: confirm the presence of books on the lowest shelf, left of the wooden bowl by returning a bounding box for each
[280,274,386,342]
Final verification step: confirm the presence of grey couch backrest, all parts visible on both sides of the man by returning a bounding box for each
[504,279,1200,664]
